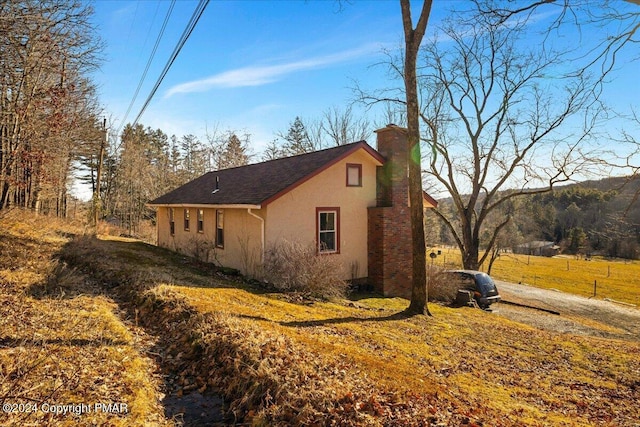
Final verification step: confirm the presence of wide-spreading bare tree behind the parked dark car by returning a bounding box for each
[421,2,636,269]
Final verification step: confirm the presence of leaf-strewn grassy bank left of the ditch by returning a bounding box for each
[0,211,166,426]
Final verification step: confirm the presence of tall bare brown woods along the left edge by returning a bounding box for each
[0,0,102,215]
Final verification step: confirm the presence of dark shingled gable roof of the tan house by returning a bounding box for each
[149,141,384,205]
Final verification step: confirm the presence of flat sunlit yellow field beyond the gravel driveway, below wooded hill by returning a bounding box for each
[434,248,640,307]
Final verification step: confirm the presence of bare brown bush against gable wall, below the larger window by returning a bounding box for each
[264,240,347,298]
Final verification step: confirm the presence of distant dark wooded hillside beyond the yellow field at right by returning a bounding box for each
[430,177,640,259]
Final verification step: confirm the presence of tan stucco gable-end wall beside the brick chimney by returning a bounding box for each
[265,150,378,279]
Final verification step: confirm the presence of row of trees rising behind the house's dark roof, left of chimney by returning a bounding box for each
[80,113,366,235]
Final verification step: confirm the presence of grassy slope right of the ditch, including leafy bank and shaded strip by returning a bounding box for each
[56,231,640,426]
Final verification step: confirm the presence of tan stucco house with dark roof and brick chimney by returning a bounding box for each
[149,125,437,297]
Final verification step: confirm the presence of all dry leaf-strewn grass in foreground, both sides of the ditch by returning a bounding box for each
[0,212,640,426]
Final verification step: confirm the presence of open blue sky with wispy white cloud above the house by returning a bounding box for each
[87,0,639,160]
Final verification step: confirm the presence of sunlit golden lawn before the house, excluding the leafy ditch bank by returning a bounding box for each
[171,285,640,426]
